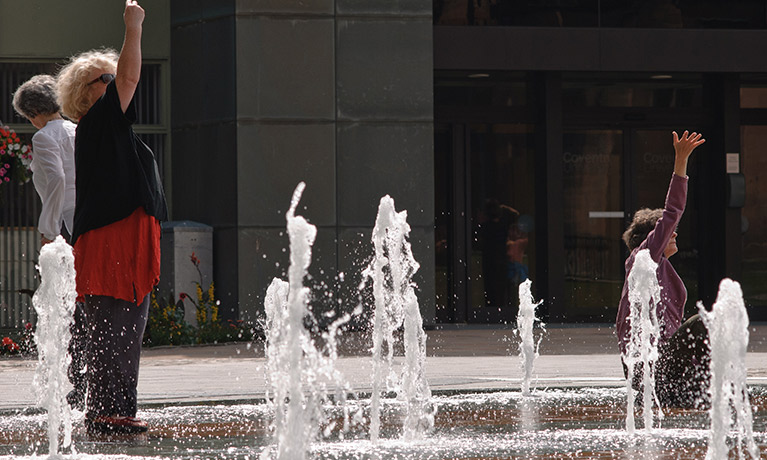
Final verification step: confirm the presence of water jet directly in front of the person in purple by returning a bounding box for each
[623,249,663,434]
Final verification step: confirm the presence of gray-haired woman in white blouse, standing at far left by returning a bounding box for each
[13,75,85,410]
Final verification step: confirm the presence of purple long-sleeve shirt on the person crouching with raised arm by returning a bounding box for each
[615,174,687,354]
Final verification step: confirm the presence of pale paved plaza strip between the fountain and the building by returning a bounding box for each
[0,323,767,410]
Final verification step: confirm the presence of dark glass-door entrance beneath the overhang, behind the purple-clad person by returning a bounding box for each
[435,71,706,323]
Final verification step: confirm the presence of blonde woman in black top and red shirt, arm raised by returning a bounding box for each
[58,0,167,433]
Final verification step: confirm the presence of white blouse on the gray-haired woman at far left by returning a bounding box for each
[29,120,77,240]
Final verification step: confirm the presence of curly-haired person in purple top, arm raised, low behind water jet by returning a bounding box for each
[615,131,710,407]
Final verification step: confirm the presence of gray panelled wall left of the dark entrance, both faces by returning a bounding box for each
[173,0,434,328]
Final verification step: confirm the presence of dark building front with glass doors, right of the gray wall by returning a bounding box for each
[434,0,767,322]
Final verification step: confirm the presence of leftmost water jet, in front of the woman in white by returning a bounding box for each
[32,236,76,458]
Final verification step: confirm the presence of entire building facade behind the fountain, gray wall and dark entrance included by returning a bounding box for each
[0,0,767,325]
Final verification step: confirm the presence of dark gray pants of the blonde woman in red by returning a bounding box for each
[85,295,149,417]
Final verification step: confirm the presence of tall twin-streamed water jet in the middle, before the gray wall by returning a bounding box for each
[363,195,434,444]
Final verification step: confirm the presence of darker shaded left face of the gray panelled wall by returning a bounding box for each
[171,0,238,318]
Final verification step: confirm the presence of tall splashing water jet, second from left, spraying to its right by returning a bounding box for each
[262,182,350,460]
